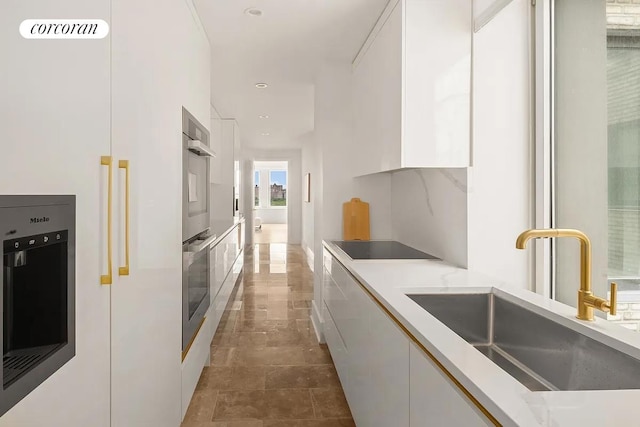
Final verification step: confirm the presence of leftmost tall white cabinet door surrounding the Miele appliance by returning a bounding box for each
[0,0,110,427]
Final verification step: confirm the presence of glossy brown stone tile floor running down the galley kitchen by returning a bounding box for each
[182,244,355,427]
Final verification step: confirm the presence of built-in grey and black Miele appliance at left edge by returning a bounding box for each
[0,196,75,415]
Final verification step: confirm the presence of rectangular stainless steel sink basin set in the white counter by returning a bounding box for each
[407,292,640,391]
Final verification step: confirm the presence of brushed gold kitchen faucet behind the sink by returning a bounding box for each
[516,228,618,321]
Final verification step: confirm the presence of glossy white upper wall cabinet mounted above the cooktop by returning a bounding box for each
[353,0,472,176]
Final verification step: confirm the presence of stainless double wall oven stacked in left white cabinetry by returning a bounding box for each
[182,108,216,355]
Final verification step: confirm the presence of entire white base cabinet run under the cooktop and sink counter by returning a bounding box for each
[323,252,493,427]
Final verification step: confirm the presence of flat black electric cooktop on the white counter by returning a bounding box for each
[333,240,440,259]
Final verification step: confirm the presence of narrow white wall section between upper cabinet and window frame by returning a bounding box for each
[468,0,533,288]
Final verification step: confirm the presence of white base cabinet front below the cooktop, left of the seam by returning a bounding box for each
[324,256,409,427]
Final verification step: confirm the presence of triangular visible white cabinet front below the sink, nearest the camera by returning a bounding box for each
[410,343,493,427]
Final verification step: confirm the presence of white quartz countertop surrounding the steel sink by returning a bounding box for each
[323,241,640,427]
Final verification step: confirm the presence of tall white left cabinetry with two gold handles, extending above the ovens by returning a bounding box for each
[0,0,210,427]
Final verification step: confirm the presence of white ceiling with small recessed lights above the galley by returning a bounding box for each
[194,0,388,148]
